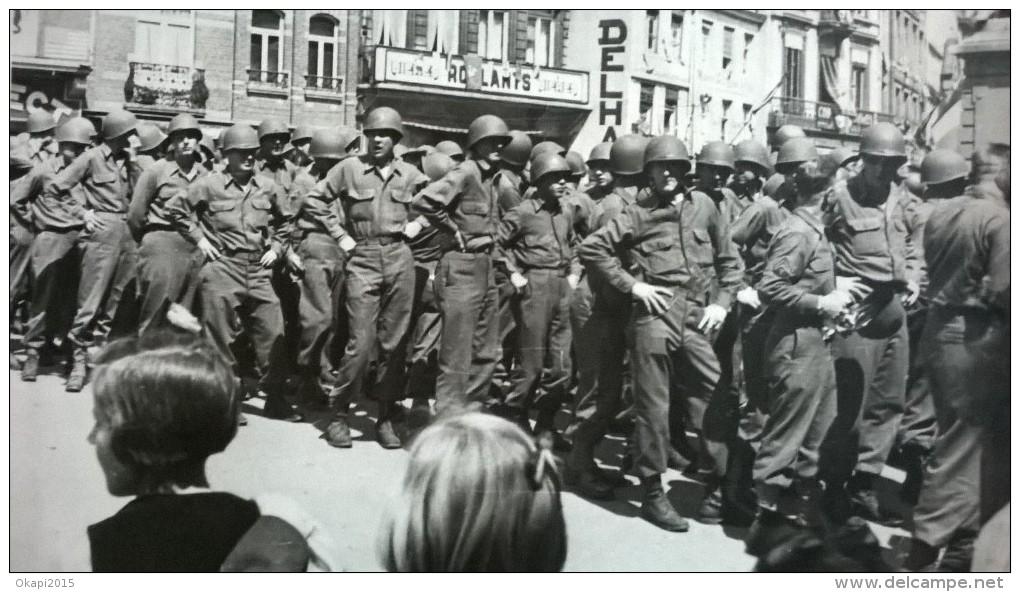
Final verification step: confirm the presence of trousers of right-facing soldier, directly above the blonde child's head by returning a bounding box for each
[436,251,500,413]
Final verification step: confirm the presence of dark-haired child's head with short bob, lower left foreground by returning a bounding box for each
[89,334,240,495]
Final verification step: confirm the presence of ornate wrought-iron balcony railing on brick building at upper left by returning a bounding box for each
[124,61,209,111]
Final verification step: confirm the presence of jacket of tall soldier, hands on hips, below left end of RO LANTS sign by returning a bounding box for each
[302,155,428,241]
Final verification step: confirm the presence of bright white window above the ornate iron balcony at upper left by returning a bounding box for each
[135,10,195,67]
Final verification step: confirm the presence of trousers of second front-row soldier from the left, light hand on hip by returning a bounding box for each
[67,212,138,349]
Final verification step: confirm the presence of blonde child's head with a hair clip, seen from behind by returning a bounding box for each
[381,413,567,572]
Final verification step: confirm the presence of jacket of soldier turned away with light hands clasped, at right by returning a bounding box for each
[758,207,835,326]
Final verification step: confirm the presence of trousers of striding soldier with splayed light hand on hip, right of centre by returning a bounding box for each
[629,291,726,478]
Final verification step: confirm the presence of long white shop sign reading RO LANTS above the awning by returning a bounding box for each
[375,47,589,103]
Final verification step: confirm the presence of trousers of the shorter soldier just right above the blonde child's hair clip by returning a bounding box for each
[506,269,570,412]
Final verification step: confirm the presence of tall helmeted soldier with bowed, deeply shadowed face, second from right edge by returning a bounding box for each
[822,122,921,521]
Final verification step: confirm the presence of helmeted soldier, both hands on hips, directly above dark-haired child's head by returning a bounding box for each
[165,124,302,422]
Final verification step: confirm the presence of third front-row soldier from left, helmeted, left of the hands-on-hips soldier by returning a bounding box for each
[128,113,208,335]
